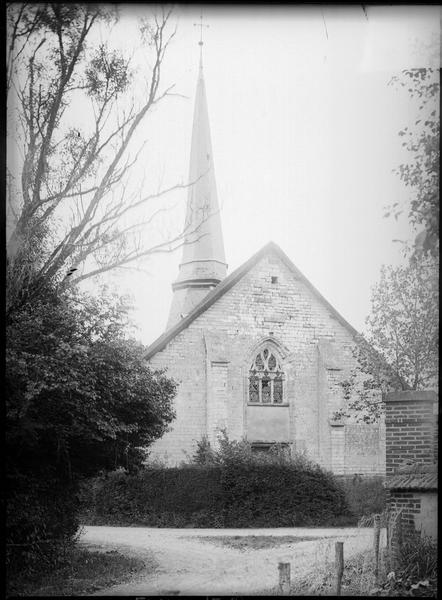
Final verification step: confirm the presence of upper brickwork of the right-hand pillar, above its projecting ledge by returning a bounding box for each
[385,391,437,475]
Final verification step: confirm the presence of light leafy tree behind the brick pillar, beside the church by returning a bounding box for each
[343,255,439,422]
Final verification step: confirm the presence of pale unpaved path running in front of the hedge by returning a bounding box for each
[81,526,386,596]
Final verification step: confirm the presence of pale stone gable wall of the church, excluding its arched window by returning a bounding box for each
[150,247,384,474]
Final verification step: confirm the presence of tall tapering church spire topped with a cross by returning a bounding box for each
[167,35,227,328]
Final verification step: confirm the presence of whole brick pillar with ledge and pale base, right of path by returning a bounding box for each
[385,391,438,537]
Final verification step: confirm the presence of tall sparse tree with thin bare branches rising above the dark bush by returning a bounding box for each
[7,3,207,310]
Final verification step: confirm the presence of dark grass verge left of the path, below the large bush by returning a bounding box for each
[7,546,155,597]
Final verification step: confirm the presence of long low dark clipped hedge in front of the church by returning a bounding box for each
[82,464,351,527]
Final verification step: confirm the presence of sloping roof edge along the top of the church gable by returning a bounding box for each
[145,242,359,360]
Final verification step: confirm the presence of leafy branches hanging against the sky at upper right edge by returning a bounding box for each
[385,68,440,256]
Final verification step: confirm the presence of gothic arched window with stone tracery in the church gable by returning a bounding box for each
[249,346,284,404]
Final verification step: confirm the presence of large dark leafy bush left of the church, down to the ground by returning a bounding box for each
[6,289,176,560]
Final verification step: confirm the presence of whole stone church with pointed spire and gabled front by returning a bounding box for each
[146,51,385,475]
